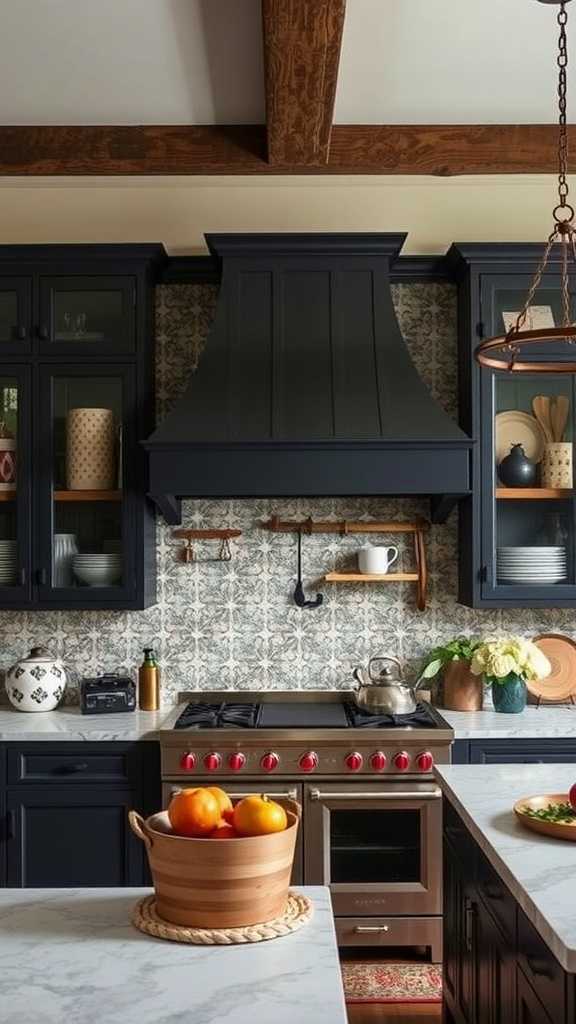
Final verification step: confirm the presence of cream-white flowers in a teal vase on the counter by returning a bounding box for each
[470,636,551,715]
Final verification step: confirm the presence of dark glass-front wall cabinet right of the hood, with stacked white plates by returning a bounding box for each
[450,244,576,607]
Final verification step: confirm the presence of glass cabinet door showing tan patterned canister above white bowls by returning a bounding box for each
[38,366,134,607]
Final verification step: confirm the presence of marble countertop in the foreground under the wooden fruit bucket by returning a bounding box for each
[0,887,347,1024]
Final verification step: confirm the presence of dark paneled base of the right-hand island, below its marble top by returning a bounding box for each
[443,801,576,1024]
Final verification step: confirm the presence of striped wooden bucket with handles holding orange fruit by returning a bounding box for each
[129,801,300,928]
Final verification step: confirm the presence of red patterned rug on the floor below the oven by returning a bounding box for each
[340,961,442,1002]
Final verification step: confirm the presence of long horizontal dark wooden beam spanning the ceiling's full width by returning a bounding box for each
[0,125,576,176]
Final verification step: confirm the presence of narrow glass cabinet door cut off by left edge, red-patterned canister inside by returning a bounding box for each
[0,367,30,606]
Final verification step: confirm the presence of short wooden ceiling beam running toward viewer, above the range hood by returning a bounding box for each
[262,0,346,167]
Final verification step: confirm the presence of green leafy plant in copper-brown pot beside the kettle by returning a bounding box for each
[420,636,483,711]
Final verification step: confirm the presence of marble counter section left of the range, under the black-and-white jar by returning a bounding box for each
[0,707,169,742]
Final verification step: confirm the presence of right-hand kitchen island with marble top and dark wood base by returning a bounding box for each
[436,764,576,1024]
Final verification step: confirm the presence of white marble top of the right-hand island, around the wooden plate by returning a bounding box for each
[436,765,576,973]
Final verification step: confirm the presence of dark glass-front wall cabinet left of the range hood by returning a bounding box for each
[0,245,164,609]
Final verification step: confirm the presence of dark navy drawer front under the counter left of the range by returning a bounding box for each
[8,743,139,785]
